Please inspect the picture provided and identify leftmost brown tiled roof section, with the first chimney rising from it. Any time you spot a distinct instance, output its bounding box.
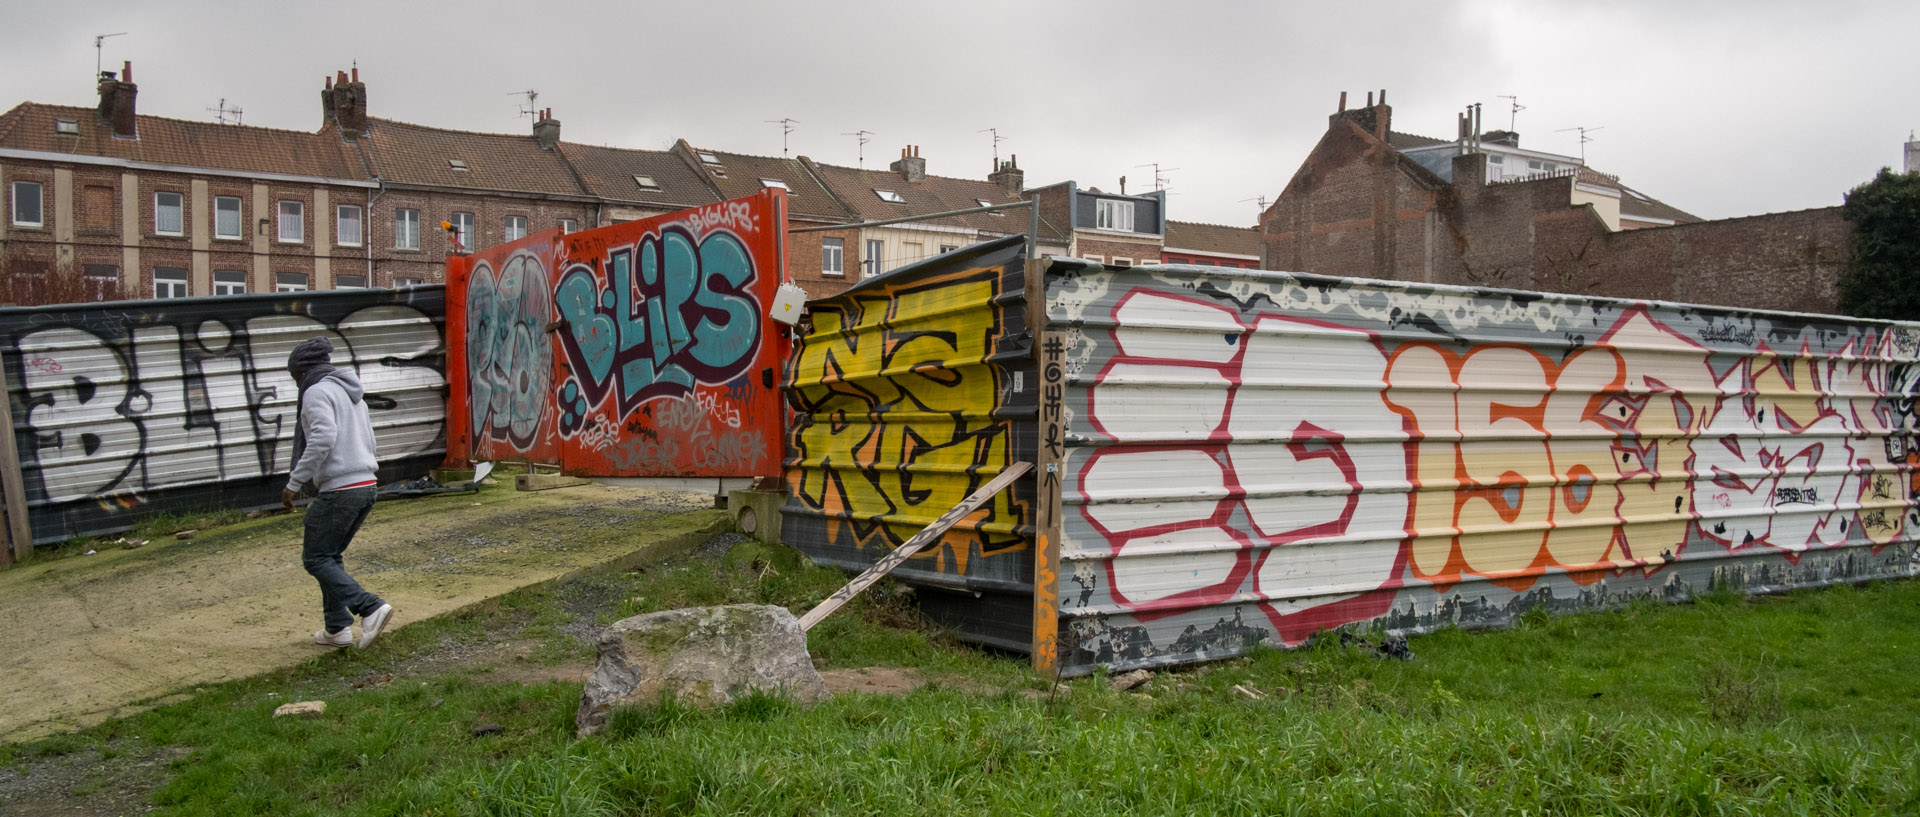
[0,102,367,178]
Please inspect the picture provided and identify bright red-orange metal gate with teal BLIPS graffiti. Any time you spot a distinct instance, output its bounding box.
[449,190,787,476]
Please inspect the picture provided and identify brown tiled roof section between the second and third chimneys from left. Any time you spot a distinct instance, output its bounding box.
[361,117,588,196]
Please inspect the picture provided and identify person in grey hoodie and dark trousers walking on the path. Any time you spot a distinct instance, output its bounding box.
[280,338,394,648]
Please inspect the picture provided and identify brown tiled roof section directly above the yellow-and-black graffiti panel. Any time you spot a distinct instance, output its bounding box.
[803,157,1027,234]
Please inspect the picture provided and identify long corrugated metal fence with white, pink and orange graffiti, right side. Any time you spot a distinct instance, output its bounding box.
[1046,263,1920,673]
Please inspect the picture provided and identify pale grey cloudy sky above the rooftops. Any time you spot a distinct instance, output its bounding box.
[0,0,1920,224]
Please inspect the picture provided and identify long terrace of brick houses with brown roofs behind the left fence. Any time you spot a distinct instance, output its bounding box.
[0,63,1240,303]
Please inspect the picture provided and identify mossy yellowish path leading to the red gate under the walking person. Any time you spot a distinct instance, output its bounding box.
[0,485,724,742]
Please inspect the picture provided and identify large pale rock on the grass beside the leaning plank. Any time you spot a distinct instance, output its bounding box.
[574,604,828,736]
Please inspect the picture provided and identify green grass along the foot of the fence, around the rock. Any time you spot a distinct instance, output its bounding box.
[0,545,1920,815]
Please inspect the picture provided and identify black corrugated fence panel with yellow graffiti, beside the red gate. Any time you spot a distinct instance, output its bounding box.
[781,236,1035,650]
